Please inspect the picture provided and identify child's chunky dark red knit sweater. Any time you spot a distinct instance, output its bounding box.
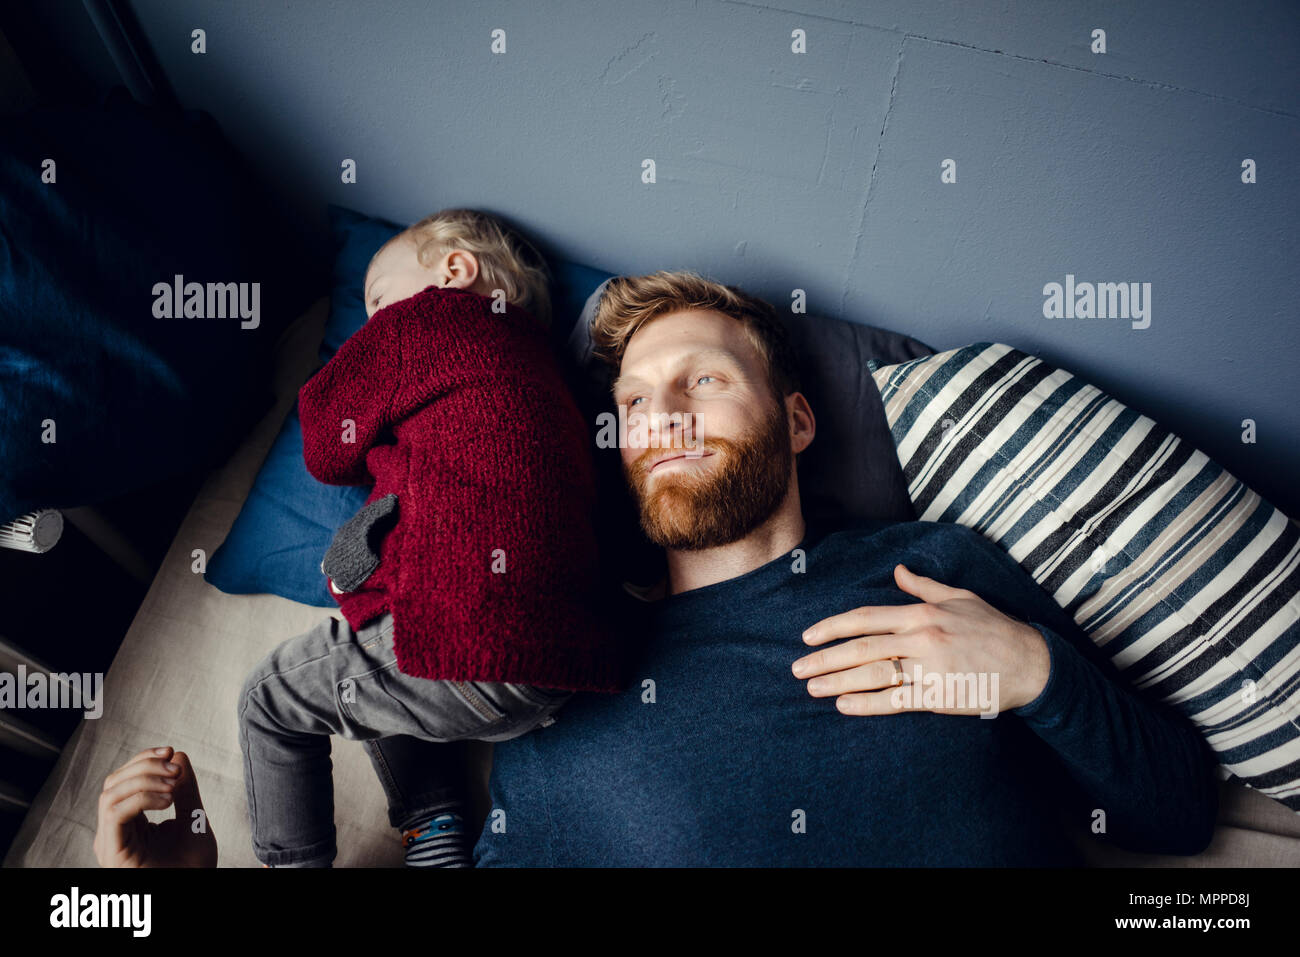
[298,286,623,692]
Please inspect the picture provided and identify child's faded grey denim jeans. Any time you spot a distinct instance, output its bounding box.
[239,614,572,867]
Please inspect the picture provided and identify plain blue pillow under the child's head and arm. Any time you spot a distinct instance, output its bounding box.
[204,205,610,607]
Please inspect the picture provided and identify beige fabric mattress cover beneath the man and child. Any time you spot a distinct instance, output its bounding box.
[4,299,1300,867]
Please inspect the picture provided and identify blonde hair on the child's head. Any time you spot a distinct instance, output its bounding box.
[384,209,551,329]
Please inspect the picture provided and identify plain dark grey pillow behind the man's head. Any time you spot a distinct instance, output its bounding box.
[568,280,935,540]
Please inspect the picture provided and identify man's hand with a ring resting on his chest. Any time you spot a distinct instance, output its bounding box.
[792,564,1052,714]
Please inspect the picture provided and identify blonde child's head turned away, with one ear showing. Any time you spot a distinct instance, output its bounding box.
[363,209,551,328]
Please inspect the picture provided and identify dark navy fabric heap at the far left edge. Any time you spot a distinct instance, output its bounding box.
[0,95,321,521]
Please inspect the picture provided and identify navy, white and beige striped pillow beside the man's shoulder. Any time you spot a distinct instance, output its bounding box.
[868,343,1300,811]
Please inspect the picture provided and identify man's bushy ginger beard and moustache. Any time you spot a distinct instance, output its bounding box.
[625,403,794,551]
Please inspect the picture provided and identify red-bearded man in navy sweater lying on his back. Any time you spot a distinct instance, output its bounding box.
[475,272,1218,866]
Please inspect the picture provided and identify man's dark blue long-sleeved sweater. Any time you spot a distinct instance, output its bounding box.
[475,521,1218,866]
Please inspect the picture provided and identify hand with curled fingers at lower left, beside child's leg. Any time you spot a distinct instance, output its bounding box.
[95,748,217,867]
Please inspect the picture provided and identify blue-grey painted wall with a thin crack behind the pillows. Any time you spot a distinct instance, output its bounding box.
[124,0,1300,515]
